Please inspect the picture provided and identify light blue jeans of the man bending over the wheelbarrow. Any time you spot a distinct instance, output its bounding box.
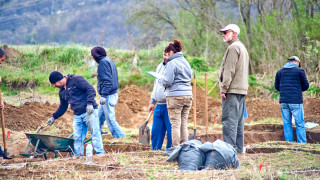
[73,109,104,156]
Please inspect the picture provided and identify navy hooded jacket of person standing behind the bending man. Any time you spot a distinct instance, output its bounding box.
[97,57,119,97]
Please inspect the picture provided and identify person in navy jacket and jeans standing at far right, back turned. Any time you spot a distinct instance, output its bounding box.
[275,56,309,143]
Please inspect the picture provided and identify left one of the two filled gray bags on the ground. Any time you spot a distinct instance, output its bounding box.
[167,140,205,171]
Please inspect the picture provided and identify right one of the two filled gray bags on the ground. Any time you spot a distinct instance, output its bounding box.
[200,139,240,169]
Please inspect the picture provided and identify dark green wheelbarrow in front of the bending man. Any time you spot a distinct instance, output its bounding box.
[20,133,92,160]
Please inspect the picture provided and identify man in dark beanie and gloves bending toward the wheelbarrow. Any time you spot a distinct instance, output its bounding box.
[47,71,104,156]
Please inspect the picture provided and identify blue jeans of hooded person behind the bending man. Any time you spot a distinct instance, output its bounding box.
[98,93,126,138]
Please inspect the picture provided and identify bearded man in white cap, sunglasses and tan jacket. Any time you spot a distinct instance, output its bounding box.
[219,24,249,153]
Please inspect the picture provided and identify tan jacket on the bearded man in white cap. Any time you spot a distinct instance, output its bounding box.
[219,39,249,95]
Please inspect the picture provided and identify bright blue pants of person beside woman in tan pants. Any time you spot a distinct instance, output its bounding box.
[151,104,172,150]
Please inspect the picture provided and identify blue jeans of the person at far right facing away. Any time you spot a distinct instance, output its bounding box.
[281,103,307,143]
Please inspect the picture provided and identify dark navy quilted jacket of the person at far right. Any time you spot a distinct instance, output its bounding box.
[274,62,309,104]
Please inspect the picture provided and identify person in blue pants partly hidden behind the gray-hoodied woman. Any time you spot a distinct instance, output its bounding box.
[149,52,172,150]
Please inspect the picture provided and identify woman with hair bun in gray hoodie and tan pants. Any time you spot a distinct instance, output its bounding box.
[160,39,192,146]
